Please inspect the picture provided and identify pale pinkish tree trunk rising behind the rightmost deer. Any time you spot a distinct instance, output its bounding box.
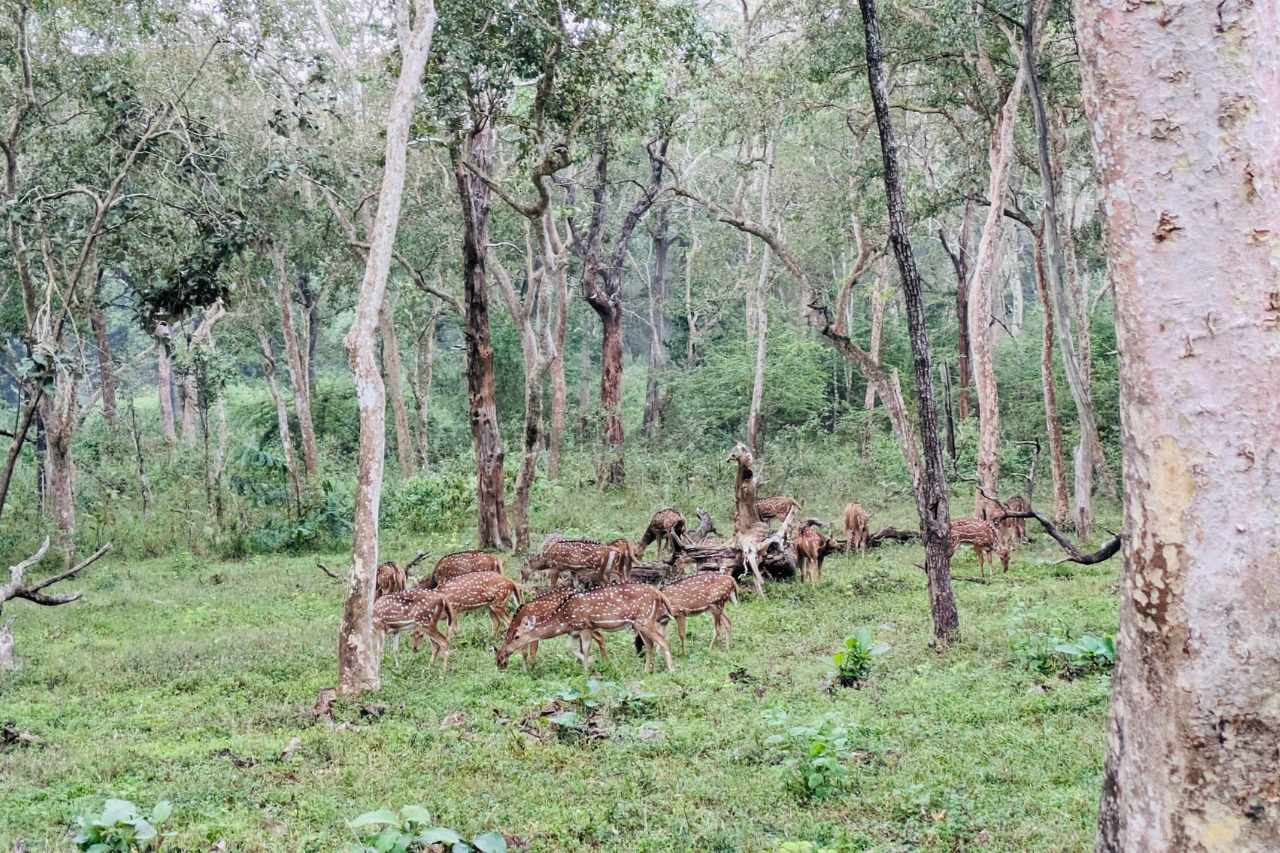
[968,53,1025,517]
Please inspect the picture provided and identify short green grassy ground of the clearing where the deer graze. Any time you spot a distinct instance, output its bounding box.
[0,479,1117,850]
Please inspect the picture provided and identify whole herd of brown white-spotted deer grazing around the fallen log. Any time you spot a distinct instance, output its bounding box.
[372,496,1029,672]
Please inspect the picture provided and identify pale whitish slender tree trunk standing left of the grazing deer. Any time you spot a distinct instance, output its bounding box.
[337,0,435,695]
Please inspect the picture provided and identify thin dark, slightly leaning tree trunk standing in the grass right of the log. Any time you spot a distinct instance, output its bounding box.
[859,0,960,648]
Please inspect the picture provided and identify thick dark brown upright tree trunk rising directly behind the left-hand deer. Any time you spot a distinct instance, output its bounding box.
[453,123,512,548]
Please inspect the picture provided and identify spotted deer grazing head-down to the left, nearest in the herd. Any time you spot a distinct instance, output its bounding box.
[497,584,673,672]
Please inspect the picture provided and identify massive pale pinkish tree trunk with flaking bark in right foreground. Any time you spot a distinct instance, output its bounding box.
[1075,0,1280,853]
